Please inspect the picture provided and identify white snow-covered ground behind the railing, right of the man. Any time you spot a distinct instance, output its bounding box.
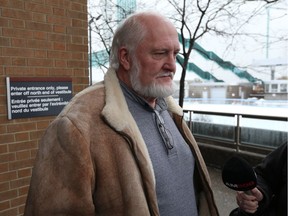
[183,99,288,133]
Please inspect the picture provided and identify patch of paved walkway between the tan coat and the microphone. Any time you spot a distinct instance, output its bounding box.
[208,167,237,216]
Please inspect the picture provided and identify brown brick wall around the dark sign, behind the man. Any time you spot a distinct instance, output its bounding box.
[0,0,89,216]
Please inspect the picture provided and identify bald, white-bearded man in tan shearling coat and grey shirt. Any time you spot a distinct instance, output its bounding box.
[25,12,218,216]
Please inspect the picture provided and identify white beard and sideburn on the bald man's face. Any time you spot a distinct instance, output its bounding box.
[130,57,176,98]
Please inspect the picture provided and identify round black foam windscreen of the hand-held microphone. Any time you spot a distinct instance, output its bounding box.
[222,156,257,191]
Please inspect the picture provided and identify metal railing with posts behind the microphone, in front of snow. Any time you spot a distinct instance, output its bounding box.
[184,110,288,166]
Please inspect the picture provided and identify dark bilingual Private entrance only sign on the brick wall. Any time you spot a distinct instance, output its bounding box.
[6,77,72,120]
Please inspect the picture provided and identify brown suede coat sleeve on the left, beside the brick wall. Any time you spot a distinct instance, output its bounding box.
[24,117,95,216]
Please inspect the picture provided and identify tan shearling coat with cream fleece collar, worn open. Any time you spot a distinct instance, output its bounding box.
[24,69,218,216]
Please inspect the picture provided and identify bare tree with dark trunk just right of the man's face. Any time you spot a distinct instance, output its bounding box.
[164,0,277,106]
